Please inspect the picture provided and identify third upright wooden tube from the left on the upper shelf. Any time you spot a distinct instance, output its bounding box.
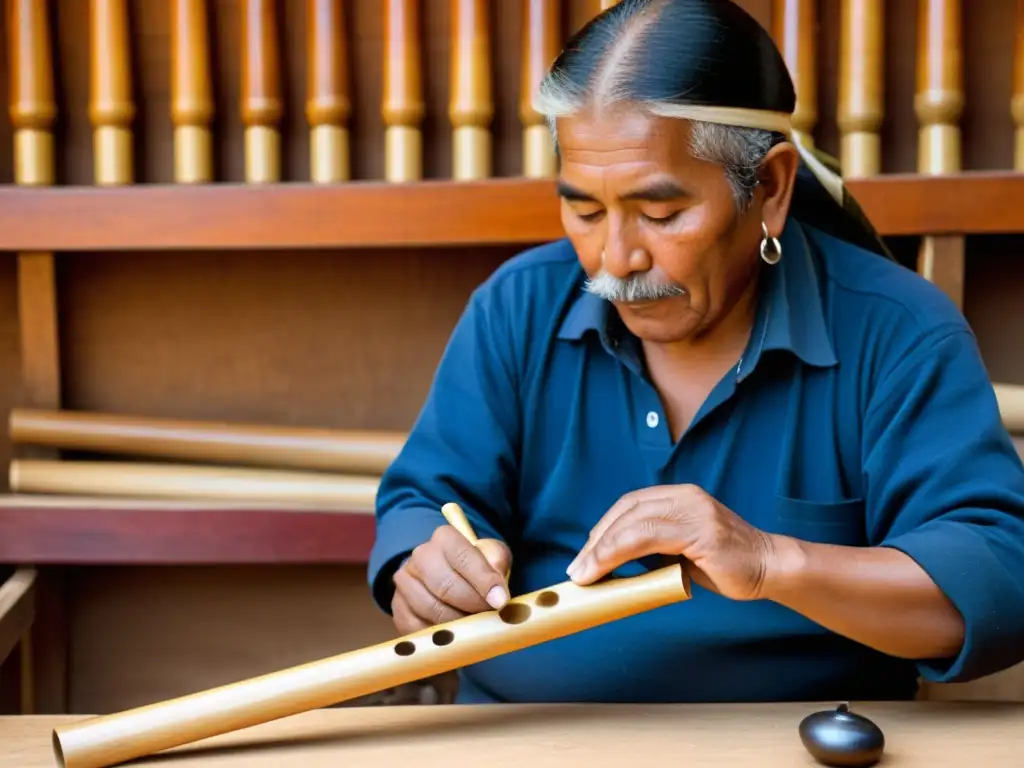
[171,0,215,184]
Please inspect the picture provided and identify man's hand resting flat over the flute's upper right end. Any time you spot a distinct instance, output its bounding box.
[567,485,775,600]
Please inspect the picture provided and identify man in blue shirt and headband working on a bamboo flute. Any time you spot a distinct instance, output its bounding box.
[369,0,1024,702]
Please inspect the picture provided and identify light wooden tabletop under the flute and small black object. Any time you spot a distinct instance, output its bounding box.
[0,701,1024,768]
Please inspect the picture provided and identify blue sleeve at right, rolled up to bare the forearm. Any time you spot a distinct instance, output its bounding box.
[864,324,1024,682]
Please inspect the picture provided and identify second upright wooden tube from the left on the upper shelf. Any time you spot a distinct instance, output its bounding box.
[89,0,135,185]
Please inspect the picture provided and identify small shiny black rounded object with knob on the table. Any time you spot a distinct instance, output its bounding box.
[800,703,886,768]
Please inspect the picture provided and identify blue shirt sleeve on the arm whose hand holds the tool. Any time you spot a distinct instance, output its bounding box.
[368,273,520,613]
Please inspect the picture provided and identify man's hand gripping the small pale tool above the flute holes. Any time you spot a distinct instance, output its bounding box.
[391,525,512,635]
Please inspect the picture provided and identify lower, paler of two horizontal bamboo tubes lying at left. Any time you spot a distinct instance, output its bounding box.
[9,459,380,512]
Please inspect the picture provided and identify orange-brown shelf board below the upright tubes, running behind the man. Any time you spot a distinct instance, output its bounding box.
[0,172,1024,251]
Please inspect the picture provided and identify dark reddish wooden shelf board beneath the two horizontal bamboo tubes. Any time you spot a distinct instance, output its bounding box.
[0,496,375,565]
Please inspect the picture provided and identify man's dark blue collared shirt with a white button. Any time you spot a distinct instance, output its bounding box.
[369,221,1024,702]
